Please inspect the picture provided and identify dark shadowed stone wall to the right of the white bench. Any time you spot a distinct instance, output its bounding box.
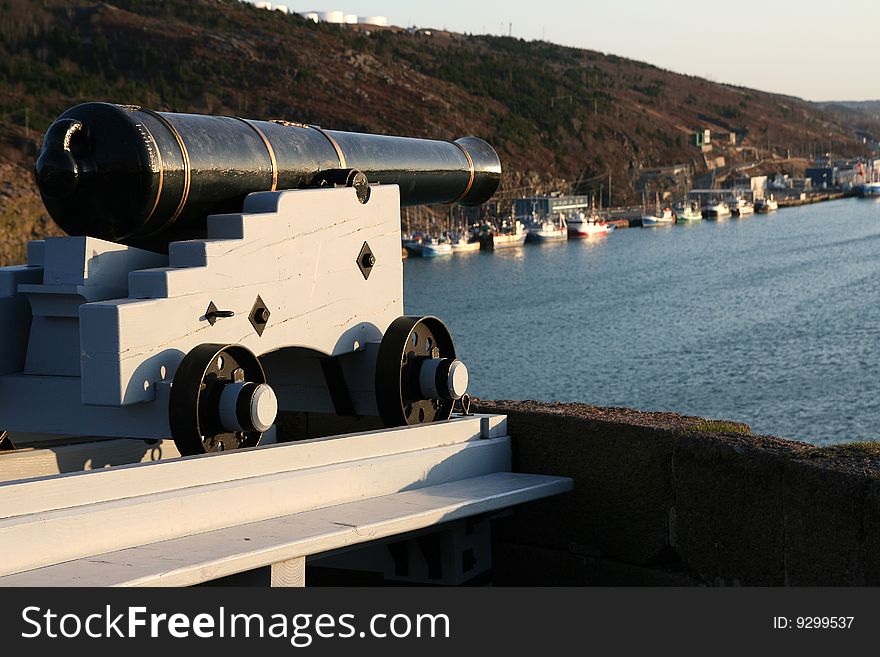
[474,401,880,586]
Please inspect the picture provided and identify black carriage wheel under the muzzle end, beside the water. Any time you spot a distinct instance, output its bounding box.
[375,315,460,427]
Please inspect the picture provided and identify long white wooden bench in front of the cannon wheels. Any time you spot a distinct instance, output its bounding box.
[0,416,571,586]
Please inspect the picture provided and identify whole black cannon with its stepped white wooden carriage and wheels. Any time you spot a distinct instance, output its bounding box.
[0,103,501,454]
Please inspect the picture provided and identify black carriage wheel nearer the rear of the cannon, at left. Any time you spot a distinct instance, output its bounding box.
[168,344,277,455]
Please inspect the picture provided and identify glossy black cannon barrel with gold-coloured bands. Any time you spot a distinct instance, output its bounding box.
[35,103,501,244]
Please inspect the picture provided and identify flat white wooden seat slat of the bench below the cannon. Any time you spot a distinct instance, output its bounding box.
[0,472,572,586]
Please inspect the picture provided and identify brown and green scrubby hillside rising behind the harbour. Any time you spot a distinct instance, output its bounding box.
[0,0,880,261]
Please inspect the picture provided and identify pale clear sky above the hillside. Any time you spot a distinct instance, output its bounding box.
[258,0,880,100]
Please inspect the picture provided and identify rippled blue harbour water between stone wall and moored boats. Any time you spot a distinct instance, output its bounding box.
[404,199,880,444]
